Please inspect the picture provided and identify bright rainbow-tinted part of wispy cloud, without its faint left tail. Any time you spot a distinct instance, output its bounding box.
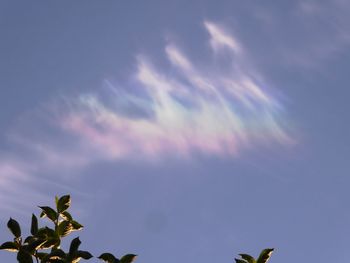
[61,21,293,159]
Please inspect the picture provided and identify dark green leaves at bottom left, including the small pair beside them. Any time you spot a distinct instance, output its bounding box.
[0,195,136,263]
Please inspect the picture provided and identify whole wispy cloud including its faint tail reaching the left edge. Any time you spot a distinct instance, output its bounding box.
[0,21,294,214]
